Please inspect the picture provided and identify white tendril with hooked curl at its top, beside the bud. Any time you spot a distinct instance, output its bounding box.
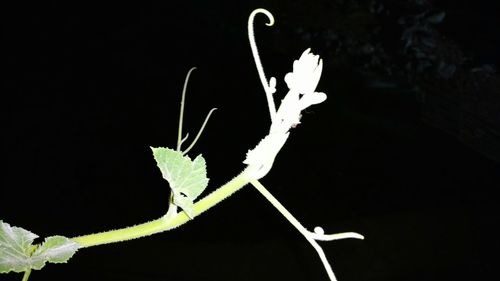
[248,8,276,122]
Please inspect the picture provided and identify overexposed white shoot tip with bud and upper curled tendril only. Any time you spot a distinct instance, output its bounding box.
[243,9,326,179]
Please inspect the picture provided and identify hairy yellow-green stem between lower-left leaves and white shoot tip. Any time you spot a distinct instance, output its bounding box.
[72,167,250,247]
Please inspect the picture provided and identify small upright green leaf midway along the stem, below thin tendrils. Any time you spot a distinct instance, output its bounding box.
[151,147,208,218]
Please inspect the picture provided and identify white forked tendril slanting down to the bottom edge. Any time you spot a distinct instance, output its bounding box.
[250,179,364,281]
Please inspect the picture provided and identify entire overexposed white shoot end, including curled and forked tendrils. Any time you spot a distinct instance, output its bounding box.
[243,9,364,281]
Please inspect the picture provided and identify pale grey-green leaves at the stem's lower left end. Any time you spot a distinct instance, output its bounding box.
[0,221,80,273]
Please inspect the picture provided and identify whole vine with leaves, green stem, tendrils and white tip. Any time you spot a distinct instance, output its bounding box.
[0,9,363,281]
